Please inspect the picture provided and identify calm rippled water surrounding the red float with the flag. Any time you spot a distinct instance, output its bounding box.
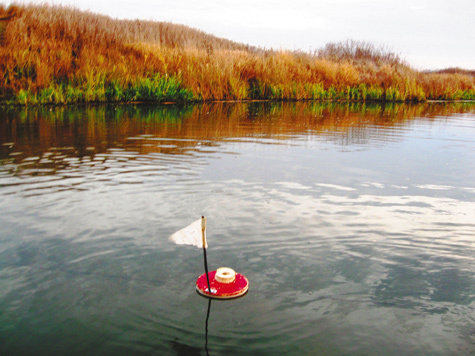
[0,103,475,355]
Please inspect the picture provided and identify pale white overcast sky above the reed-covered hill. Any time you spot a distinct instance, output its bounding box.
[4,0,475,70]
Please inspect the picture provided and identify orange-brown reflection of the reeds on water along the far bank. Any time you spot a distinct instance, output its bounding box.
[0,102,474,170]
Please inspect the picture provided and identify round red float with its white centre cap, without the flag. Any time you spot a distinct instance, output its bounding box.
[196,267,249,299]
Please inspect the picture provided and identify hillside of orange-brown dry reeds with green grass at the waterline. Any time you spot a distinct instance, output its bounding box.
[0,5,475,105]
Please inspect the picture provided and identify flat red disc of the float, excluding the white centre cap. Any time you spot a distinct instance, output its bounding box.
[196,271,249,299]
